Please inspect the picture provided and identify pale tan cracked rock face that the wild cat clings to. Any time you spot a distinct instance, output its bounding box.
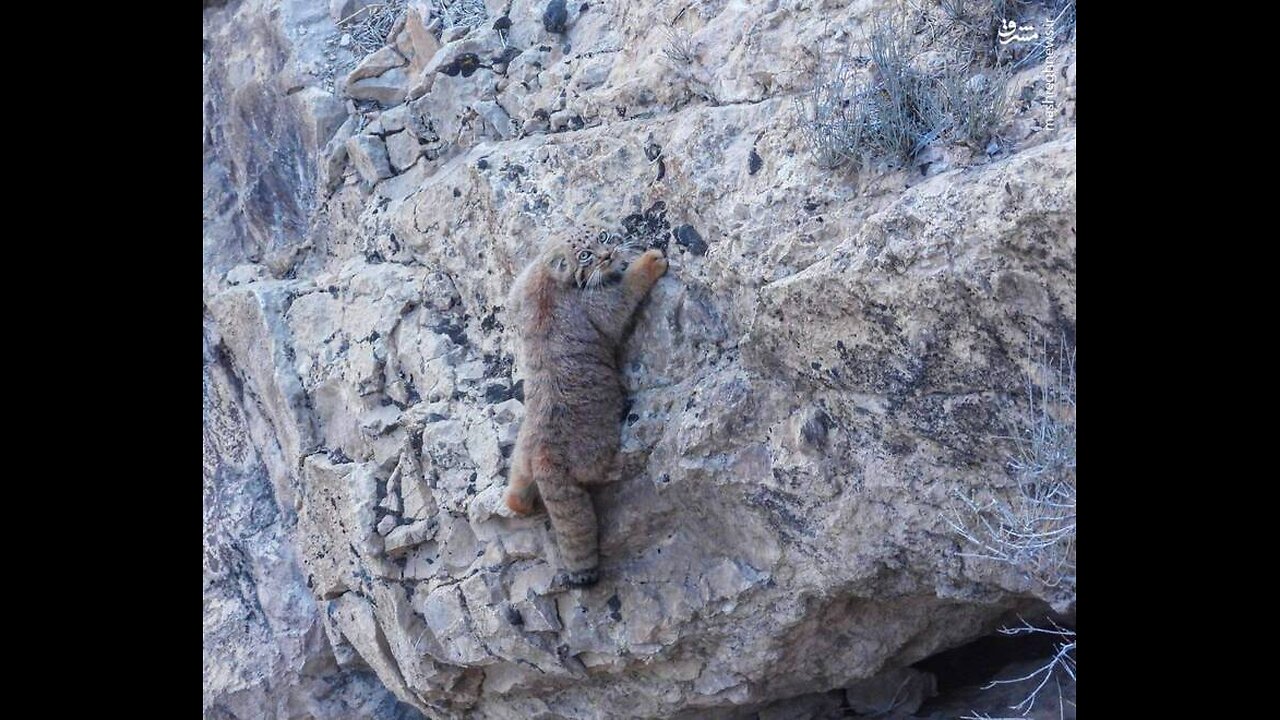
[204,0,1075,719]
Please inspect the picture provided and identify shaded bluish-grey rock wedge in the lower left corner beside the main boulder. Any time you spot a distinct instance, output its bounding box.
[204,334,416,720]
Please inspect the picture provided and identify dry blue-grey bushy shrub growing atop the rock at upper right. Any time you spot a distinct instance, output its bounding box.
[797,0,1075,169]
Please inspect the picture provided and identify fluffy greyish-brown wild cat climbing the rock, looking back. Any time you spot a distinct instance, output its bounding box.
[504,226,667,587]
